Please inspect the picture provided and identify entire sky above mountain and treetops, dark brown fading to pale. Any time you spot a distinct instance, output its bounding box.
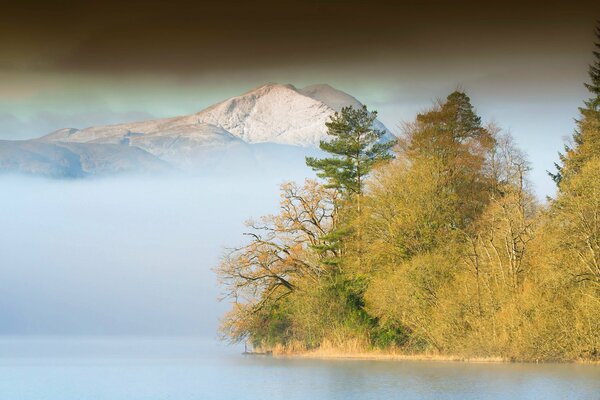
[0,0,600,196]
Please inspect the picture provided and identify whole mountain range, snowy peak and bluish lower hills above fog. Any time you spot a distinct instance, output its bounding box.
[0,83,387,176]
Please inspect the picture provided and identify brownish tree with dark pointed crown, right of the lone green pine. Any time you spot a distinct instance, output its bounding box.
[401,91,496,229]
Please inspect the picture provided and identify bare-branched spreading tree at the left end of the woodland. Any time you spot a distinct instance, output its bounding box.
[216,180,339,338]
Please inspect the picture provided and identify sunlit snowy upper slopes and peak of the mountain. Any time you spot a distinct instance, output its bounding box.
[41,83,390,149]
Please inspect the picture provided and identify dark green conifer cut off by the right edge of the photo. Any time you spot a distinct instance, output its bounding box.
[549,23,600,188]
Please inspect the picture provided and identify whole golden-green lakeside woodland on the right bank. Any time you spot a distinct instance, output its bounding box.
[216,28,600,361]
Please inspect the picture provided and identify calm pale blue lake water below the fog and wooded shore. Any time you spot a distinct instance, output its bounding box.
[0,338,600,400]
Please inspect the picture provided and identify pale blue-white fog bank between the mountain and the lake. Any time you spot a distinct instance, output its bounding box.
[0,170,310,337]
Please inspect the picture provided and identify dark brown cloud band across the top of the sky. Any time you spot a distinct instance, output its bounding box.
[0,0,600,75]
